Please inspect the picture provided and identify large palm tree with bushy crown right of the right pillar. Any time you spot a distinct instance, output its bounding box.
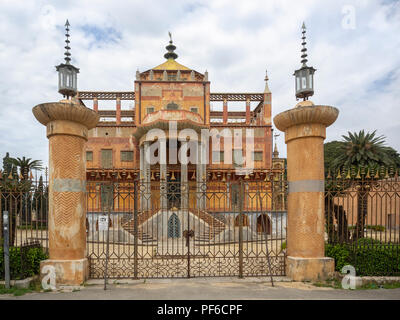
[332,130,400,239]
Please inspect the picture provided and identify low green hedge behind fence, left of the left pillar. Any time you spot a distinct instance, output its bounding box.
[0,247,48,280]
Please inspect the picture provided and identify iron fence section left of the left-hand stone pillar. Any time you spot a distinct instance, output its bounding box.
[0,175,49,279]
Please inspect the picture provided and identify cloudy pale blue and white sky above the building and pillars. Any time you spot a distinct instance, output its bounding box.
[0,0,400,171]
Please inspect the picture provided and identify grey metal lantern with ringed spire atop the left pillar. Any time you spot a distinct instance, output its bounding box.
[56,20,79,99]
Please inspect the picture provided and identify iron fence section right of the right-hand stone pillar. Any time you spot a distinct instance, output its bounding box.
[325,174,400,275]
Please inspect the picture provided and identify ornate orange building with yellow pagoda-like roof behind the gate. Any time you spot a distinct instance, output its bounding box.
[77,39,285,238]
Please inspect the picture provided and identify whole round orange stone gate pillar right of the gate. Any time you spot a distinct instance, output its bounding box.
[274,101,339,281]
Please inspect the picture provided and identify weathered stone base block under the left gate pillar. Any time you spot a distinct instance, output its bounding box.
[40,258,89,287]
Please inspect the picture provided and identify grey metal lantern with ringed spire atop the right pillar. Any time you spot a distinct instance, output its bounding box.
[293,22,316,101]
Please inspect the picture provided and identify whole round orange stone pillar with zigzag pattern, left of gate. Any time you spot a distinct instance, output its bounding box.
[32,100,99,285]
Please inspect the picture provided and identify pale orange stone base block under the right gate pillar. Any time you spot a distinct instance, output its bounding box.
[286,257,335,281]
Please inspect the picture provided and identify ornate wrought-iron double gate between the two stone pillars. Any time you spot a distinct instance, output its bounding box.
[87,173,286,278]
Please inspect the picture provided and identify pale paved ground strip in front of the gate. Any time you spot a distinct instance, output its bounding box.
[0,278,400,300]
